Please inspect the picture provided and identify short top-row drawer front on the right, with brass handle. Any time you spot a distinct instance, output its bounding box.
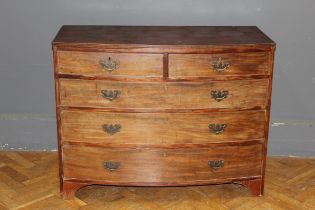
[169,52,270,78]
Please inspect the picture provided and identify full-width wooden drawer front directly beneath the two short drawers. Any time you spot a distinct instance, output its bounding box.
[59,79,268,109]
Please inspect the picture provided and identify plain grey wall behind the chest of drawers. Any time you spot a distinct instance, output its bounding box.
[0,0,315,155]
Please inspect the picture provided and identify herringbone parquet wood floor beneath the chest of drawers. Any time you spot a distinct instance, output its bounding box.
[0,152,315,210]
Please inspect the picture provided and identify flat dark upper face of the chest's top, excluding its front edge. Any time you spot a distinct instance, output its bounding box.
[53,25,275,46]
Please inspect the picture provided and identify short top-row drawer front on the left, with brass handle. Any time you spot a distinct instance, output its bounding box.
[58,51,163,77]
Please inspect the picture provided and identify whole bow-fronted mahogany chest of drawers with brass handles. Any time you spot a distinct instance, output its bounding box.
[53,26,275,199]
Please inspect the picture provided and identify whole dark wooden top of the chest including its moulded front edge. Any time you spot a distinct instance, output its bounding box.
[52,26,275,53]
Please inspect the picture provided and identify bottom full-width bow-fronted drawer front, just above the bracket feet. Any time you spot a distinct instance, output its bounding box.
[62,144,262,185]
